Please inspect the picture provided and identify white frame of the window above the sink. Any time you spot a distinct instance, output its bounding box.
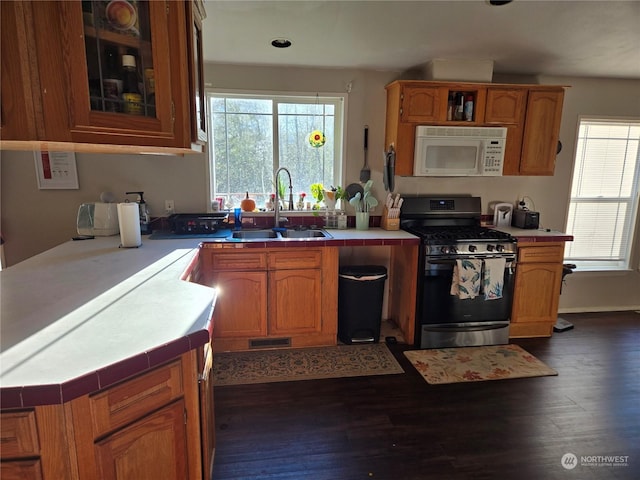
[205,87,348,211]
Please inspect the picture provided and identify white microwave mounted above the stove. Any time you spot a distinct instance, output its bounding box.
[413,126,507,177]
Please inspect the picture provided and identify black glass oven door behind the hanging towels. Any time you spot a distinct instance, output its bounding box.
[418,260,515,324]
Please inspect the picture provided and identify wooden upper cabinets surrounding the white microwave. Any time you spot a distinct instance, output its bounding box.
[385,80,564,176]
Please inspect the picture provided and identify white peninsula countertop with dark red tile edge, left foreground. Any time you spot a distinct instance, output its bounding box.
[0,236,216,408]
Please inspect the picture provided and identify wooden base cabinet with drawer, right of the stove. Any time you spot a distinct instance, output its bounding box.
[509,242,564,338]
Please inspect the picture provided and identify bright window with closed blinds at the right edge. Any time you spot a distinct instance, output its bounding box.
[565,118,640,270]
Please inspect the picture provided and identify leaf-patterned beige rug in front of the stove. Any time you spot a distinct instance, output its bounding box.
[404,345,558,384]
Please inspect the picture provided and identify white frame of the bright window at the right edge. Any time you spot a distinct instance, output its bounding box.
[564,115,640,272]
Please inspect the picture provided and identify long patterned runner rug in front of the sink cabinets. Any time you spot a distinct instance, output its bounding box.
[213,343,404,386]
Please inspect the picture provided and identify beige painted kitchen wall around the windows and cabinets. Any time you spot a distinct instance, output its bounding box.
[1,0,640,480]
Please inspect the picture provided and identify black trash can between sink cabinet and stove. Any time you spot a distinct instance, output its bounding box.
[338,265,387,344]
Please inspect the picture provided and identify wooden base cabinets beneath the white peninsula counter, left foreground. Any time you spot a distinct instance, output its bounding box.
[0,350,213,480]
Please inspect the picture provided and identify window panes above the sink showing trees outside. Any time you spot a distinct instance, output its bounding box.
[208,92,344,208]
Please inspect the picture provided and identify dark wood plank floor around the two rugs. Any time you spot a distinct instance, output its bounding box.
[214,312,640,480]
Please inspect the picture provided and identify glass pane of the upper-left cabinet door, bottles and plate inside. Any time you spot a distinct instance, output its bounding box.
[82,0,156,117]
